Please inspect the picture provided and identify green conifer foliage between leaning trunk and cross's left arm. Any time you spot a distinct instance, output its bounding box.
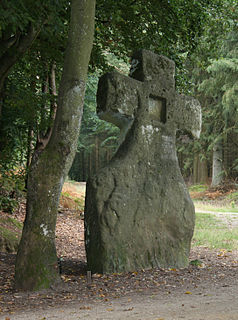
[69,74,119,181]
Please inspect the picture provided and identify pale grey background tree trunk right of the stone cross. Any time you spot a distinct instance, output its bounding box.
[212,140,223,187]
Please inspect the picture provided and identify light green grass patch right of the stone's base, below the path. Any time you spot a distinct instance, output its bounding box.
[192,213,238,250]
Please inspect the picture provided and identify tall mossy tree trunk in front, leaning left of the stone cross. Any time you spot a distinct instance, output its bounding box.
[15,0,95,290]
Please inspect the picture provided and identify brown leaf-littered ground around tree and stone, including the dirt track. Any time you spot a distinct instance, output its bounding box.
[0,184,238,320]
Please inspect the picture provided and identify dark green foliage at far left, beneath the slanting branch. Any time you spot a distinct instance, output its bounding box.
[0,55,58,166]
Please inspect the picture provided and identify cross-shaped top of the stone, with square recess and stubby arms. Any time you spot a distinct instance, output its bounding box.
[97,50,201,137]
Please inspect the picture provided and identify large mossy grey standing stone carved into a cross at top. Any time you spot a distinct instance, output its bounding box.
[85,50,201,273]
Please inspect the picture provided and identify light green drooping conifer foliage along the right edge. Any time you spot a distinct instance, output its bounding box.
[199,27,238,178]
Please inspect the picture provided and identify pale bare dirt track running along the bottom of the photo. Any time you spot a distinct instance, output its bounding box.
[1,278,238,320]
